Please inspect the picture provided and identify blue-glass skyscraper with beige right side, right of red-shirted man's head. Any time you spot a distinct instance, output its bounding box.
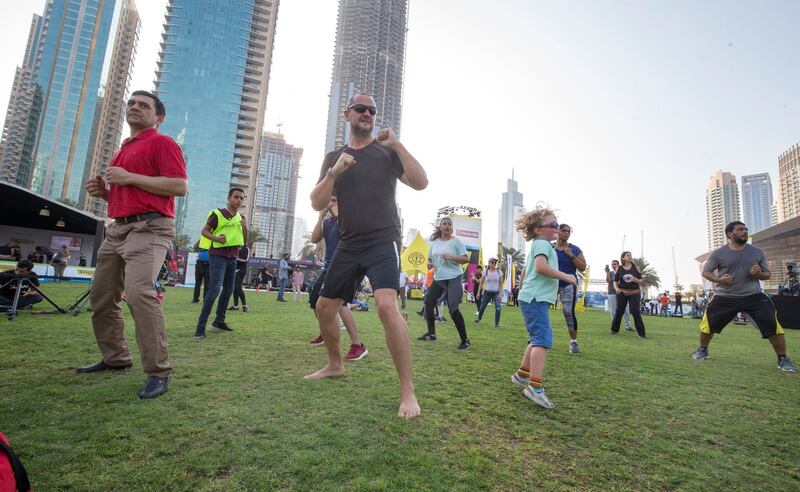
[155,0,279,238]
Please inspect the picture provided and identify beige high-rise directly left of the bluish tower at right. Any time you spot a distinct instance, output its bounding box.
[706,171,741,250]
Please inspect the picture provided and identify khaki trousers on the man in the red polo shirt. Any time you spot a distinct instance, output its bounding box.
[90,217,175,377]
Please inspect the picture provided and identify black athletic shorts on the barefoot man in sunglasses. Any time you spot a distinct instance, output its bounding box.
[319,241,400,301]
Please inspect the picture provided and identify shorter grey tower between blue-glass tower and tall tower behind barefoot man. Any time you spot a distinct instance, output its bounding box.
[251,132,303,258]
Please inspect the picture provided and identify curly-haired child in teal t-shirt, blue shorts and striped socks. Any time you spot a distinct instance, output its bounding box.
[511,206,577,409]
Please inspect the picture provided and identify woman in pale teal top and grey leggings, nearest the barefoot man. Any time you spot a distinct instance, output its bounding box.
[418,217,470,350]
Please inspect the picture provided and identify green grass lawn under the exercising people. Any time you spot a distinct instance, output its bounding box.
[0,285,800,491]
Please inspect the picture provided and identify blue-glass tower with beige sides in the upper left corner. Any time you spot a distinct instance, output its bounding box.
[3,0,139,209]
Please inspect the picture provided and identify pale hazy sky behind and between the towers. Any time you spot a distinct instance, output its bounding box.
[0,0,800,290]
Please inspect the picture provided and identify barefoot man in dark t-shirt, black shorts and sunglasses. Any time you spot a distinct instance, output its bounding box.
[306,94,428,418]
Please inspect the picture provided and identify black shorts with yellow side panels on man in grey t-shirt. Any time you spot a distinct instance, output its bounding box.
[700,293,783,338]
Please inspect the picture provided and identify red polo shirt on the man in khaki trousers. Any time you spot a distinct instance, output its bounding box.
[108,128,186,218]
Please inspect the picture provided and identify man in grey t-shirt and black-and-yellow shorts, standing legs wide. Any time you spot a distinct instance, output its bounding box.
[692,221,797,372]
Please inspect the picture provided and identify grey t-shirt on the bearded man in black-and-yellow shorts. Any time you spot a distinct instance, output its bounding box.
[703,244,769,297]
